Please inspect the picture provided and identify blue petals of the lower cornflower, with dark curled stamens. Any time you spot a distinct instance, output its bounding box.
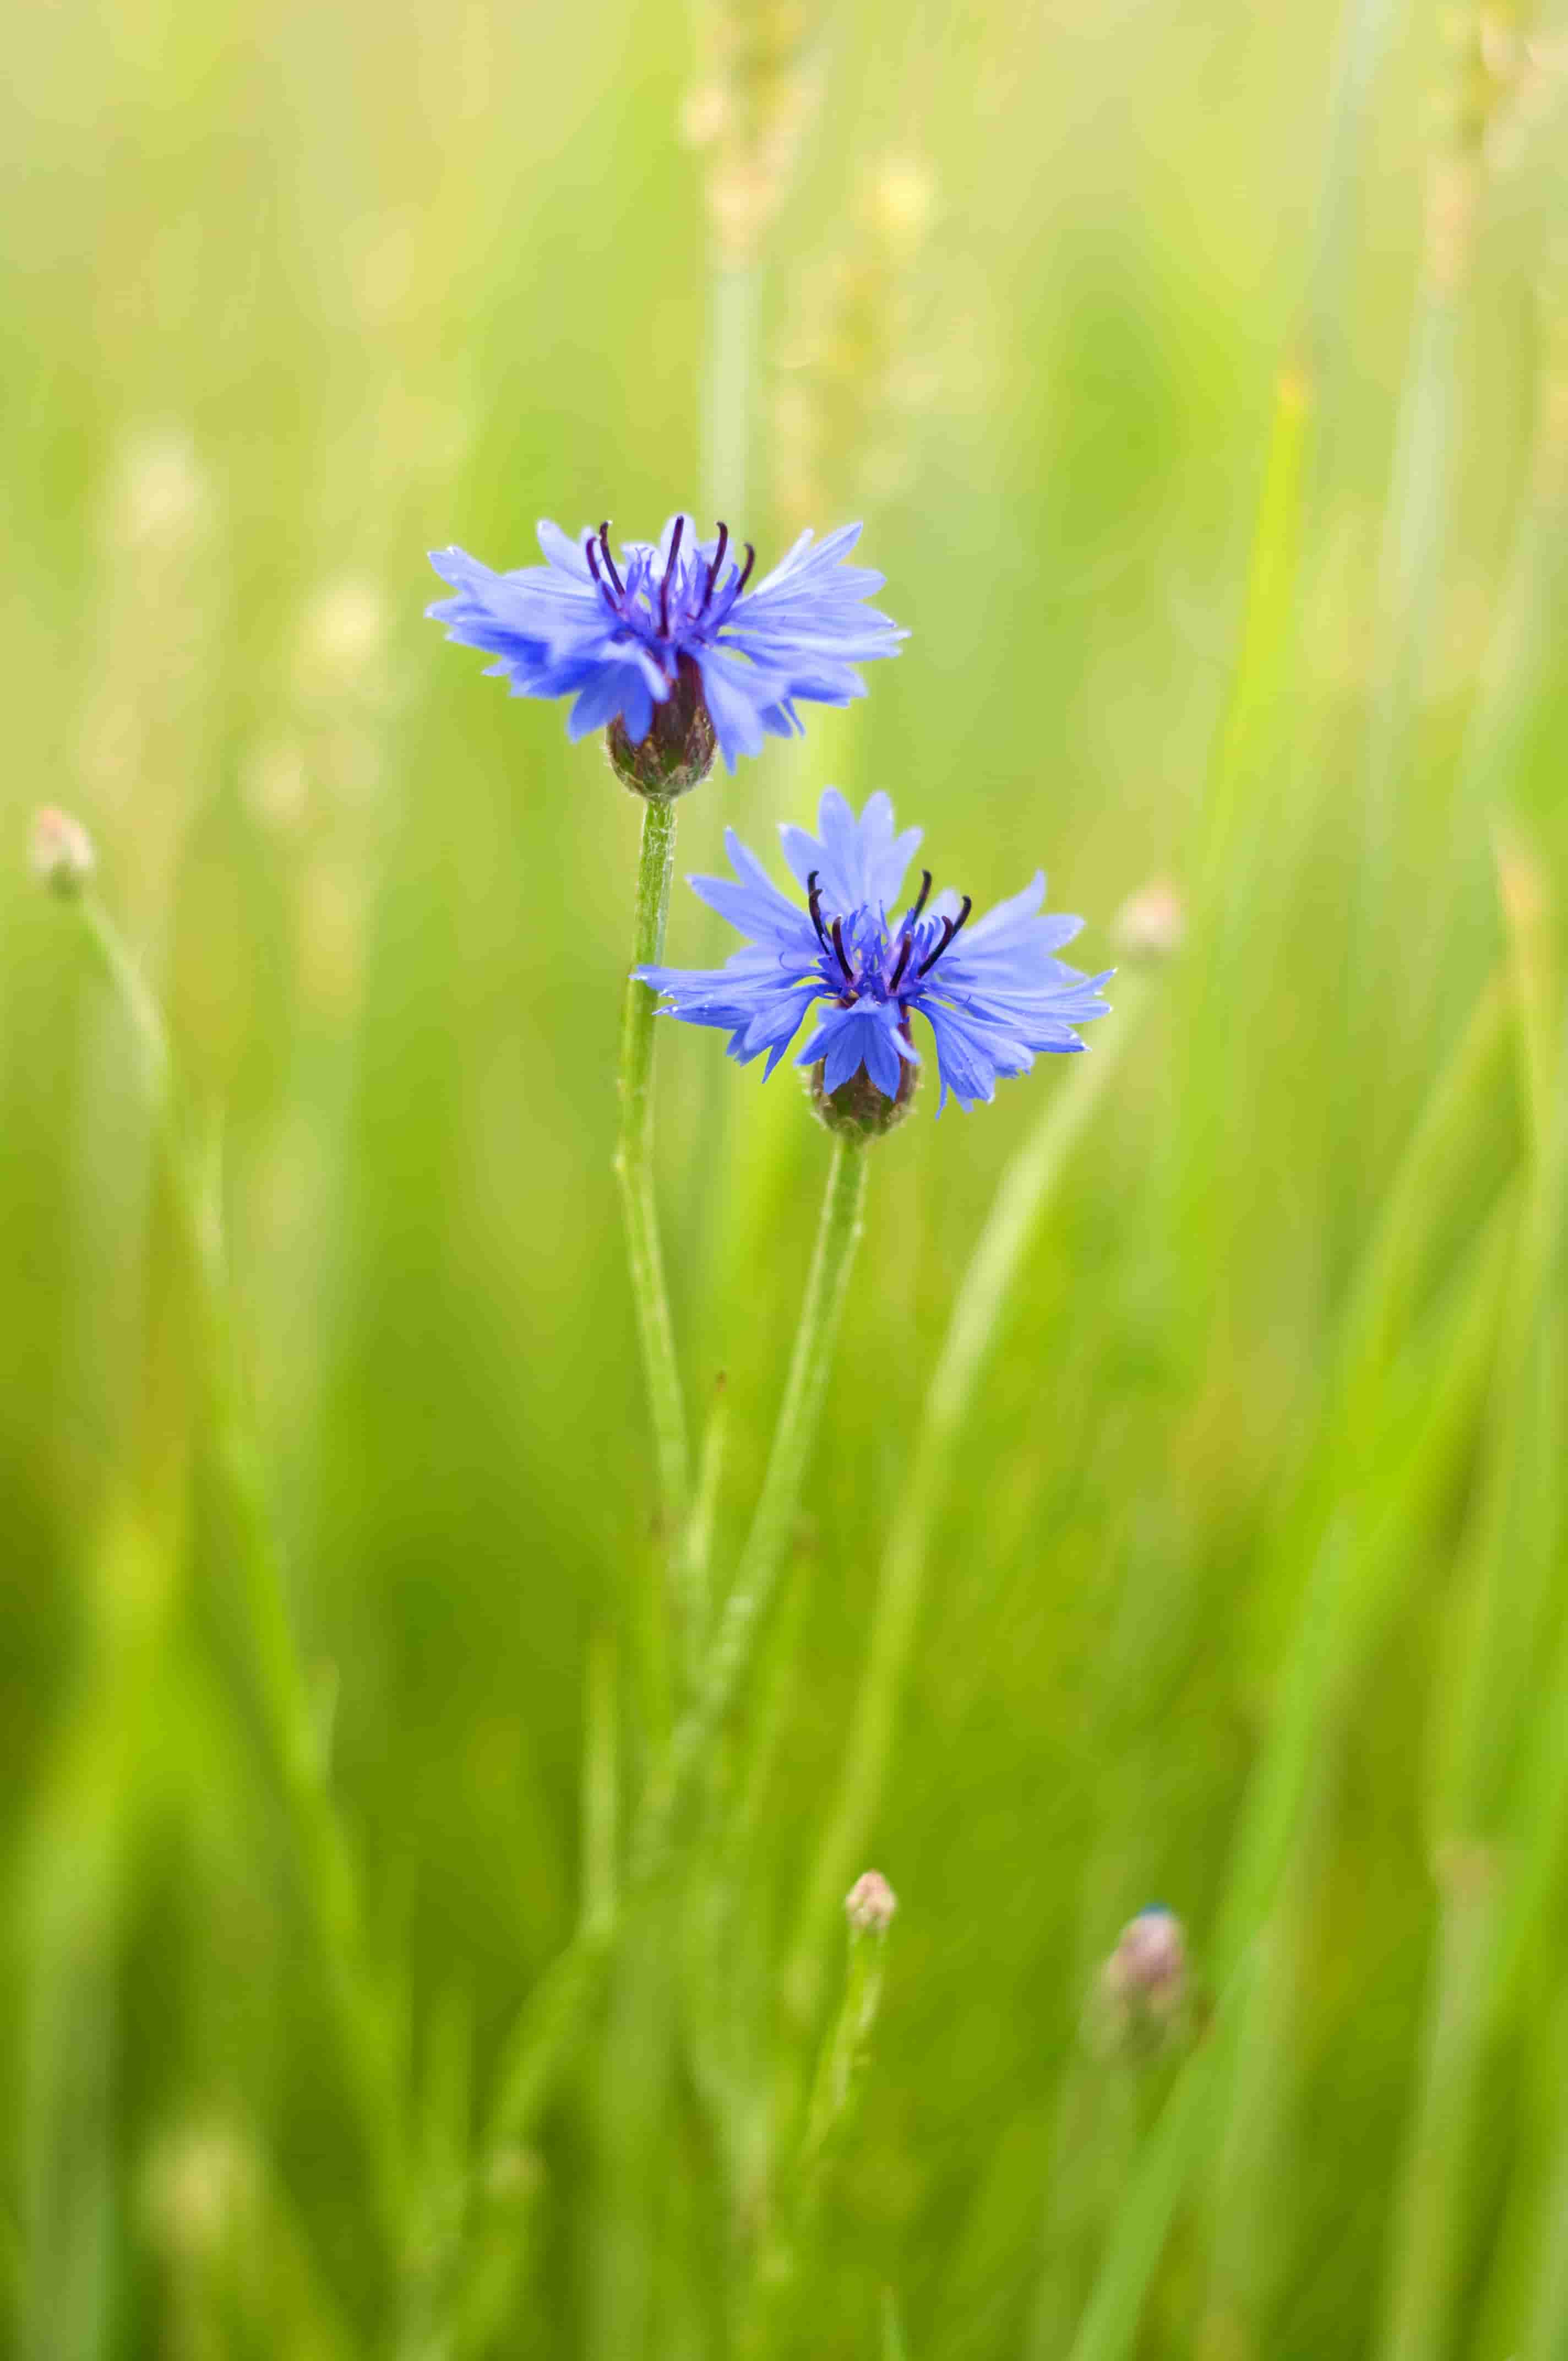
[633,786,1110,1112]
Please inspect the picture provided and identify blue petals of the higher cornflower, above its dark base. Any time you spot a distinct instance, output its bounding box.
[427,515,905,770]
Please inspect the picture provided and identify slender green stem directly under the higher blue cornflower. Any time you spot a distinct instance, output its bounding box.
[616,796,689,1535]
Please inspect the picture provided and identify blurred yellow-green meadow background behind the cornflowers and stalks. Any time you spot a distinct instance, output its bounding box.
[0,0,1568,2361]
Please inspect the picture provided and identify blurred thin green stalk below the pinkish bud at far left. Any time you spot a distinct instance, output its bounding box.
[78,897,404,2257]
